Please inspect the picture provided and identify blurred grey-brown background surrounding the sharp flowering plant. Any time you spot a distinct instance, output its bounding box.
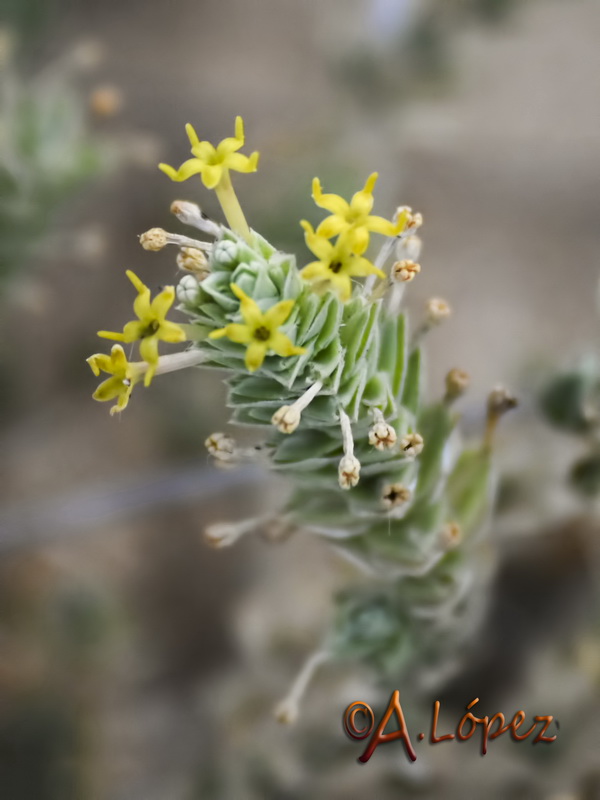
[0,0,600,800]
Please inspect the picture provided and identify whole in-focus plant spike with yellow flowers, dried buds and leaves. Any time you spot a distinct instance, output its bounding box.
[88,117,514,720]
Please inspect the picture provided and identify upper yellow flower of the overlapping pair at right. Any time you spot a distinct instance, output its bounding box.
[313,172,406,255]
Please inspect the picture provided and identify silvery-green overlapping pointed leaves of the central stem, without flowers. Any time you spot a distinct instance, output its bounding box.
[179,230,490,673]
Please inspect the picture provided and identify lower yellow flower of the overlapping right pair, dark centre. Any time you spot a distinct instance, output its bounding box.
[300,220,385,303]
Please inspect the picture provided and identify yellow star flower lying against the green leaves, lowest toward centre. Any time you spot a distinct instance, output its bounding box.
[209,283,306,372]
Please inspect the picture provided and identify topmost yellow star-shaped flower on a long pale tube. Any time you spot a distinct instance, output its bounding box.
[158,117,258,189]
